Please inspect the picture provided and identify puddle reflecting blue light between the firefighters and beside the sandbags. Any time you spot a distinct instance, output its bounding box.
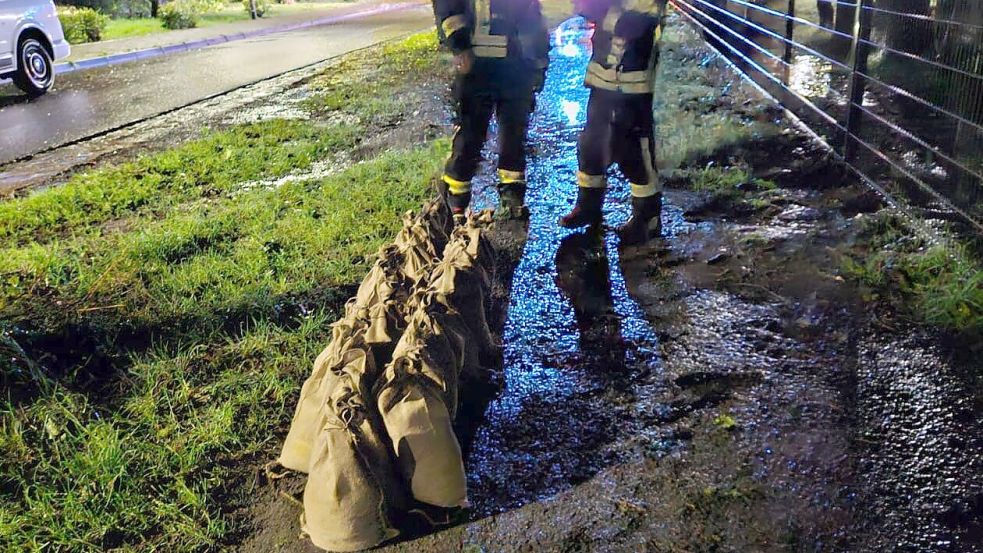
[467,20,693,516]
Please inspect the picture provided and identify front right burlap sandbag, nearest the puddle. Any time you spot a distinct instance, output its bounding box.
[376,364,468,508]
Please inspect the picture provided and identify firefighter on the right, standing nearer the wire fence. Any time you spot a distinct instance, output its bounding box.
[560,0,666,246]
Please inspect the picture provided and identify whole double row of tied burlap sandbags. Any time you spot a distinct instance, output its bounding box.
[279,204,496,551]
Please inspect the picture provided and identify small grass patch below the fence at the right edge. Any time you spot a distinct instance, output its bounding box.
[842,212,983,338]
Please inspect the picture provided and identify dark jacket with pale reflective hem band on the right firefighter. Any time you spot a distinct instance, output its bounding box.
[578,0,666,94]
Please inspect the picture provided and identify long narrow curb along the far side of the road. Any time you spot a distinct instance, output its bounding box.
[55,2,424,75]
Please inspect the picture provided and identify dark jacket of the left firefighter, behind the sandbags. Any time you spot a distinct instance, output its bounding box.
[433,0,550,71]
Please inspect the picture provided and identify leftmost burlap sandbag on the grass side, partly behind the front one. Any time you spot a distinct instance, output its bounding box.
[277,319,378,472]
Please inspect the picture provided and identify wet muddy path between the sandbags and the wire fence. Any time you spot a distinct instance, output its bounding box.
[241,14,983,552]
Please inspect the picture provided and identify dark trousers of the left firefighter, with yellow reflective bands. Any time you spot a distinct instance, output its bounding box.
[444,67,534,194]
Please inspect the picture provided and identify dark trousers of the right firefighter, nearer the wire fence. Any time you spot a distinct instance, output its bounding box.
[577,88,662,198]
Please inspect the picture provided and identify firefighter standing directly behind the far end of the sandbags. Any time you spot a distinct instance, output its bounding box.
[433,0,549,221]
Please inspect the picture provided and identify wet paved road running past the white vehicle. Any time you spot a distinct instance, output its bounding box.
[0,4,433,164]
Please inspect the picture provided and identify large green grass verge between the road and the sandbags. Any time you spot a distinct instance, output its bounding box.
[0,31,448,551]
